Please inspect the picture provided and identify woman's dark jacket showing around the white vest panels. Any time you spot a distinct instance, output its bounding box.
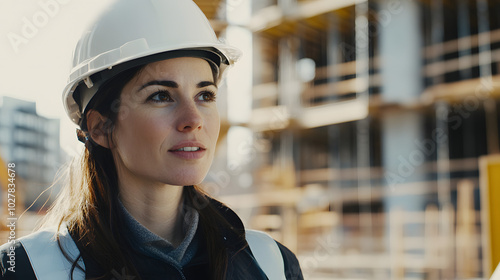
[0,200,303,280]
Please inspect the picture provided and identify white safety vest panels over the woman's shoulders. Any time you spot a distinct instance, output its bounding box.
[18,228,286,280]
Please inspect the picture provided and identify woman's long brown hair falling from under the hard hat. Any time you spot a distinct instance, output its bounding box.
[42,63,242,279]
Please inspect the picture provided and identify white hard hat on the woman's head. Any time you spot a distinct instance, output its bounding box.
[63,0,241,124]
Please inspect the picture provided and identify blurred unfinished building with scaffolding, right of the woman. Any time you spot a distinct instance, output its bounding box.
[211,0,500,279]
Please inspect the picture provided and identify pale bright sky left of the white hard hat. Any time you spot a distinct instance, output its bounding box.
[0,0,115,155]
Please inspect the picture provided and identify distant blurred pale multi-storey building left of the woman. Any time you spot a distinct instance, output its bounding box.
[0,97,66,210]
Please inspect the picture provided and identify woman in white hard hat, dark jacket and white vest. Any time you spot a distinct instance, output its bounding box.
[1,0,302,280]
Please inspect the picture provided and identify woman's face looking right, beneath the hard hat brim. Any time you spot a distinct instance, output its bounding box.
[111,57,220,186]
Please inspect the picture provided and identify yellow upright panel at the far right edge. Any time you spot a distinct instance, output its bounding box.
[479,155,500,278]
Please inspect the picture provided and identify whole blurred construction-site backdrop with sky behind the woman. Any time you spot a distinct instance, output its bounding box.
[0,0,500,280]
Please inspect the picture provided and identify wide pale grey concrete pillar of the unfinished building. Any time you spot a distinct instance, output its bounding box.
[378,0,428,210]
